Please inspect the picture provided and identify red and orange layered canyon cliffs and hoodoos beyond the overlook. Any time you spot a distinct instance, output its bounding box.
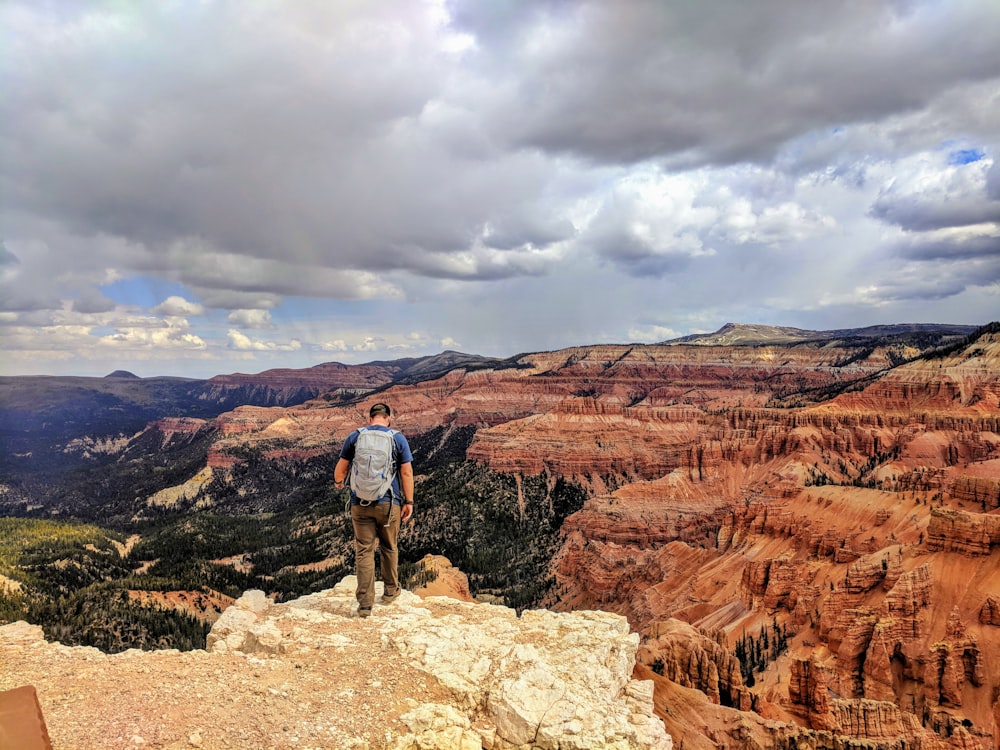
[1,324,1000,750]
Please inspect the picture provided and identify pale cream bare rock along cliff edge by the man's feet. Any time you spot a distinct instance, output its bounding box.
[208,576,672,750]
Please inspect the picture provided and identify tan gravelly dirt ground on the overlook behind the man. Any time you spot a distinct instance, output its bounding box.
[0,612,451,750]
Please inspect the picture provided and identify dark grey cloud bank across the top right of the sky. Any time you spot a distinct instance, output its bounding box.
[455,0,1000,164]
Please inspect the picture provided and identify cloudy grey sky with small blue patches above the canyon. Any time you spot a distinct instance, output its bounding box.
[0,0,1000,378]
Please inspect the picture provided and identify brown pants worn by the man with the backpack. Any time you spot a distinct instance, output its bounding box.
[351,503,399,609]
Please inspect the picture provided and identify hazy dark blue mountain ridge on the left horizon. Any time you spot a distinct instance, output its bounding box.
[0,351,502,496]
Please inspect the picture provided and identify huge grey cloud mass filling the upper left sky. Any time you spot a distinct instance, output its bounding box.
[0,3,596,294]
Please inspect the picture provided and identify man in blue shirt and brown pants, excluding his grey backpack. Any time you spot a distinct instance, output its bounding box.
[333,403,413,617]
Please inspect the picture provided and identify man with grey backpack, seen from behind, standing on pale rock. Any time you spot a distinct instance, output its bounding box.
[333,403,413,617]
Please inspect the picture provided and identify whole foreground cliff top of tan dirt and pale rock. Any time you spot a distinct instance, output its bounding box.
[0,576,673,750]
